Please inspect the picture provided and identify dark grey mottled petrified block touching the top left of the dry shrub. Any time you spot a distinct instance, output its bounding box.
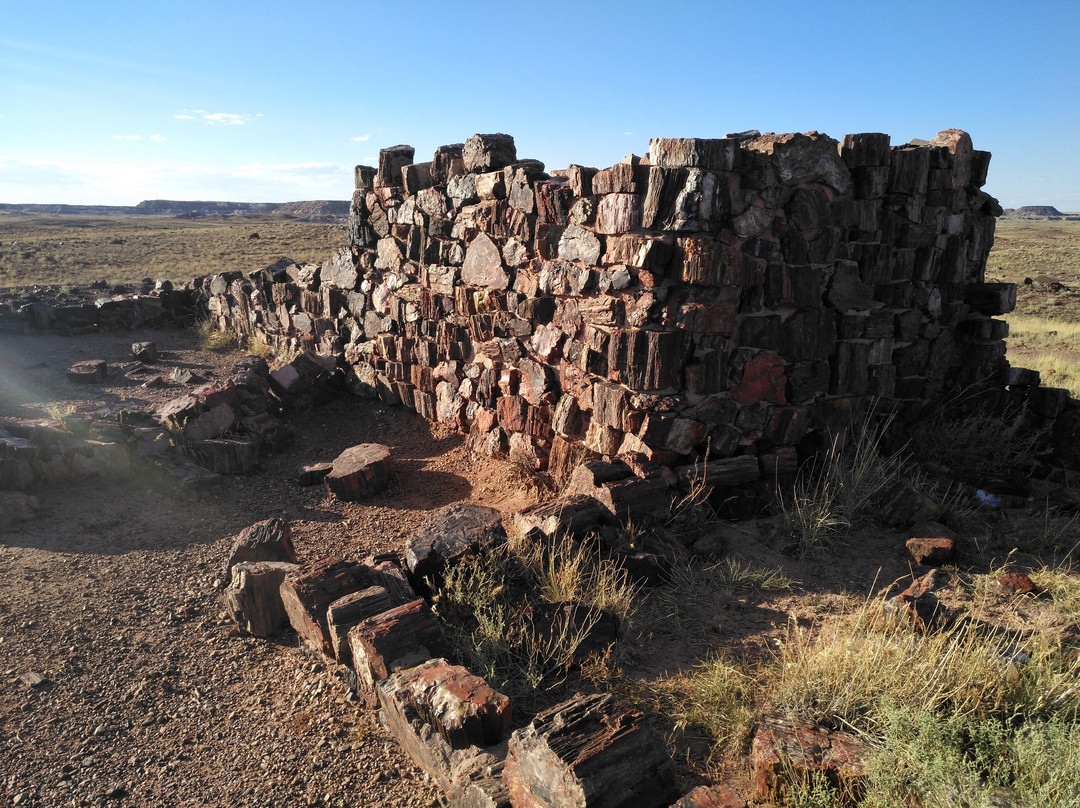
[405,504,507,580]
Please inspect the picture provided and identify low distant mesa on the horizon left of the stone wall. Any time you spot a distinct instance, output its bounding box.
[0,199,349,221]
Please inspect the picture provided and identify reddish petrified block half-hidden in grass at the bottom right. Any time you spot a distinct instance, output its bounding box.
[751,715,869,800]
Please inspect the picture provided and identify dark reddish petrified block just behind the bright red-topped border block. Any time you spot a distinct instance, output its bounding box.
[348,600,441,706]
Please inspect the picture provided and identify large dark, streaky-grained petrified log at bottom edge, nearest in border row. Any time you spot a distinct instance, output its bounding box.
[502,693,678,808]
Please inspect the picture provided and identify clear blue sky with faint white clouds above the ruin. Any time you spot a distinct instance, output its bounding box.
[0,0,1080,211]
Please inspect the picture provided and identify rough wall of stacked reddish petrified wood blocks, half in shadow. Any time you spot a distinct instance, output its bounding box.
[202,130,1015,476]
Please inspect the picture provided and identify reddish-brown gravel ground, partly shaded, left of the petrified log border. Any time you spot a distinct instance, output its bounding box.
[0,332,536,807]
